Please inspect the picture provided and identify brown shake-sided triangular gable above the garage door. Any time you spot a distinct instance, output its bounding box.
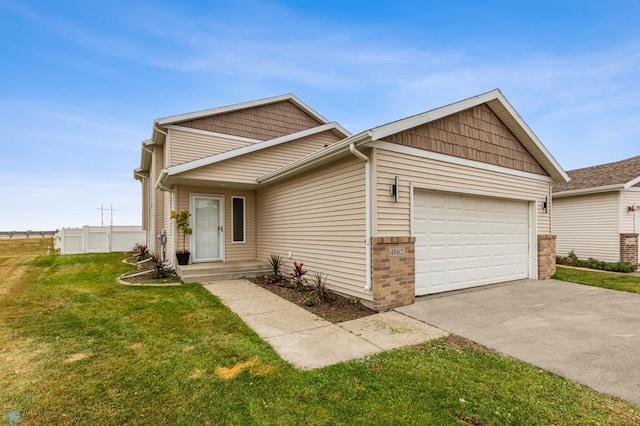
[385,104,547,176]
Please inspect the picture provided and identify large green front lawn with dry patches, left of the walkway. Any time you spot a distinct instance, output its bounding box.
[0,254,640,426]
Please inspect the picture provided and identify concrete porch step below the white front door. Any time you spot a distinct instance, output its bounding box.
[176,261,270,283]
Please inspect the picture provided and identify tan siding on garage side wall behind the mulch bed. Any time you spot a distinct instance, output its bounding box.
[257,157,364,300]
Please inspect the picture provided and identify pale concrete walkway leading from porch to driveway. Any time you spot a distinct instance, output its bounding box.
[204,279,448,369]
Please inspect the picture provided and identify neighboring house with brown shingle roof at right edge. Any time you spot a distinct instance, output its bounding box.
[552,156,640,264]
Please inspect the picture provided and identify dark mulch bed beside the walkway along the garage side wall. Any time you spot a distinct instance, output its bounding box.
[248,277,376,323]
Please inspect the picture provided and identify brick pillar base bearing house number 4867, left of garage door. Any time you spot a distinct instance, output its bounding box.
[371,237,416,311]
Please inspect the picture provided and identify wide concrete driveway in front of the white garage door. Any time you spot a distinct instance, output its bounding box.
[396,280,640,406]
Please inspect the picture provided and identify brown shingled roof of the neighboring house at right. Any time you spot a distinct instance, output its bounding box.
[553,155,640,197]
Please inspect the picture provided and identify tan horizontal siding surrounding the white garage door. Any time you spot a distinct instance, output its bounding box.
[374,149,551,236]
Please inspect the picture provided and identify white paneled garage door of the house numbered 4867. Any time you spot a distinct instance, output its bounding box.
[413,191,529,295]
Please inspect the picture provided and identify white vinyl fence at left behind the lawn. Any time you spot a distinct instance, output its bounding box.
[54,226,147,254]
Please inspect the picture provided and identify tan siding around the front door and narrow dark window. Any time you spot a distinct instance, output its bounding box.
[176,186,257,262]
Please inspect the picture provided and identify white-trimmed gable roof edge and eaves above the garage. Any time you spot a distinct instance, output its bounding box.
[258,89,569,183]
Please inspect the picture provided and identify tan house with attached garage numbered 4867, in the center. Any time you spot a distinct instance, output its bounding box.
[134,90,568,310]
